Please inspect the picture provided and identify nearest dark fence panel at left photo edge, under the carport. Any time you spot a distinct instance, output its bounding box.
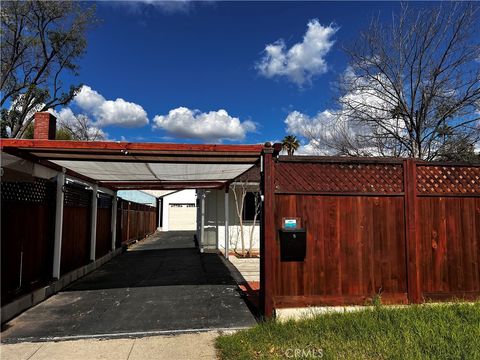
[1,179,55,304]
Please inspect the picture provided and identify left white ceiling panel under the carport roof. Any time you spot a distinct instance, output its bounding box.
[52,160,158,181]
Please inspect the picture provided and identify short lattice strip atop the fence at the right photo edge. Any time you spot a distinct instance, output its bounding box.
[417,165,480,194]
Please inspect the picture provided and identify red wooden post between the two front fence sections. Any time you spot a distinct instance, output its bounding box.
[403,159,422,303]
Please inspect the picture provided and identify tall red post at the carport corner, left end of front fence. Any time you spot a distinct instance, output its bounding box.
[260,147,275,318]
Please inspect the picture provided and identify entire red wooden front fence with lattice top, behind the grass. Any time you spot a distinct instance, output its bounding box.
[261,153,480,315]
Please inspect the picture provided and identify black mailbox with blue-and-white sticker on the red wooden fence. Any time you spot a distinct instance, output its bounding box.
[278,218,307,261]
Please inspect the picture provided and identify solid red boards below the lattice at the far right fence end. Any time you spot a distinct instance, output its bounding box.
[419,197,480,293]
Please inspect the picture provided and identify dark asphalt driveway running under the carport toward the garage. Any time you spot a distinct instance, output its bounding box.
[1,232,256,342]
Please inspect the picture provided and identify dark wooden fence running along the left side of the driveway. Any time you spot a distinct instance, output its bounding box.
[1,178,156,304]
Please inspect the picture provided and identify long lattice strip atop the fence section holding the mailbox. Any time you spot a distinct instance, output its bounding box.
[275,162,403,194]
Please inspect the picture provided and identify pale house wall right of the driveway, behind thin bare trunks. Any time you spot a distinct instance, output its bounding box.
[202,186,260,252]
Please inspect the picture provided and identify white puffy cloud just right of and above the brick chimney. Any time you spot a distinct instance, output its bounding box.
[74,85,148,127]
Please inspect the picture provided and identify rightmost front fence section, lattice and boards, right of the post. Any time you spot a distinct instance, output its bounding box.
[416,163,480,300]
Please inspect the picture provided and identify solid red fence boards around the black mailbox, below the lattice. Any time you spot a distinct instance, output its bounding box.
[274,195,407,307]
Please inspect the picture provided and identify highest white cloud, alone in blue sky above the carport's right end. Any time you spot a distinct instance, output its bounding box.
[256,19,338,86]
